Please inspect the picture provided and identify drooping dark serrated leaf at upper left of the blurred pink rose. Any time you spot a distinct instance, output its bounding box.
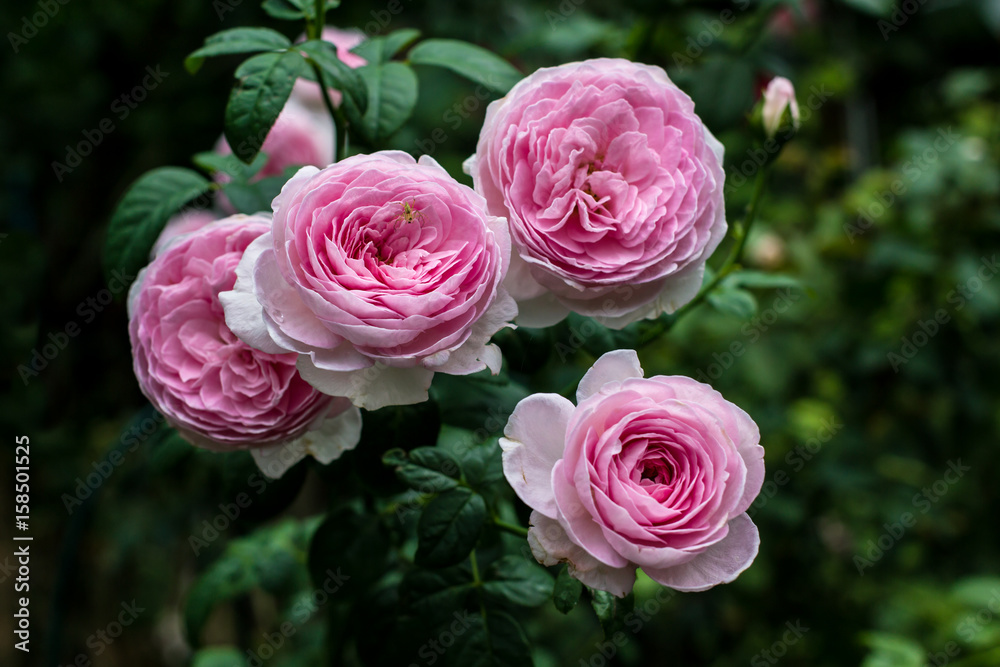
[226,51,306,163]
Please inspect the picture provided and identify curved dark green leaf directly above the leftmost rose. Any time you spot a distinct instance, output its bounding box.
[104,167,212,288]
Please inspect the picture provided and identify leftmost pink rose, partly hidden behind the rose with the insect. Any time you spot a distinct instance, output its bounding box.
[129,215,361,476]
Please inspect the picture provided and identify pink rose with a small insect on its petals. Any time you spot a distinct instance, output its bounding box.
[221,151,517,410]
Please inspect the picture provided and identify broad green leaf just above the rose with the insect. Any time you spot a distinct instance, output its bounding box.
[356,62,417,145]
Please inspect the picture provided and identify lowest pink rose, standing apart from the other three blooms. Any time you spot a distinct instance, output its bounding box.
[500,350,764,597]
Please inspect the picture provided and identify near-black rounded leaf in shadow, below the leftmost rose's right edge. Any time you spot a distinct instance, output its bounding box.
[309,507,389,596]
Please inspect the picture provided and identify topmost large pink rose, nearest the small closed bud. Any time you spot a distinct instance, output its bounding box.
[466,58,726,328]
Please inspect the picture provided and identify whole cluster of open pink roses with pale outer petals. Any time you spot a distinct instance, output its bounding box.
[129,44,764,595]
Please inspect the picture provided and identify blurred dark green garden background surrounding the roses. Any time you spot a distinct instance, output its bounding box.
[0,0,1000,667]
